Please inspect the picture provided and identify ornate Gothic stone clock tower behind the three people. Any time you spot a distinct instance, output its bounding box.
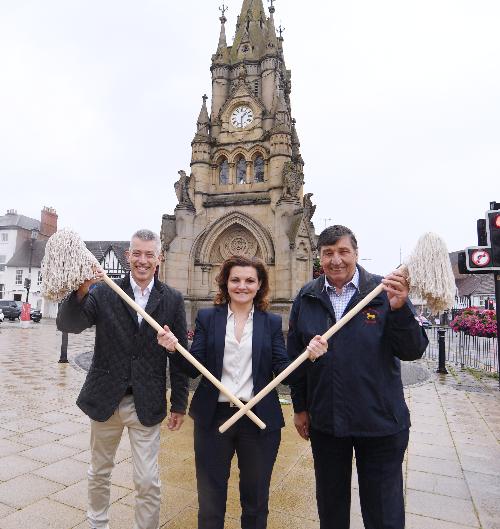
[160,0,315,325]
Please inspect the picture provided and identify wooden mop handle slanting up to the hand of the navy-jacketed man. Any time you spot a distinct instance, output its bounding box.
[219,284,384,433]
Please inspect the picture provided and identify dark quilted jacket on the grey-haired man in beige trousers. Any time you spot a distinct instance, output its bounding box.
[57,275,188,426]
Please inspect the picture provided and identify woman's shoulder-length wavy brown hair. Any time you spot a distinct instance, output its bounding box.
[214,255,269,311]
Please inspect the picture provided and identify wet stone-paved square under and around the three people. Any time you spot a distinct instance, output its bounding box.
[0,320,500,529]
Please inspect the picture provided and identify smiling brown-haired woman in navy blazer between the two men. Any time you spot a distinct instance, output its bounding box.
[158,256,327,529]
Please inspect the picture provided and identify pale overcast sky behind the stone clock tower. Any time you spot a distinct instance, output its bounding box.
[0,0,500,273]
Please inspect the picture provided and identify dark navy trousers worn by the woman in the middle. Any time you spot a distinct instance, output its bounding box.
[194,403,281,529]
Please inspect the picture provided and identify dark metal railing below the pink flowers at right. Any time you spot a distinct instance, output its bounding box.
[424,326,498,373]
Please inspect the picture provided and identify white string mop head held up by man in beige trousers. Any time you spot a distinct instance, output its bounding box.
[41,229,99,302]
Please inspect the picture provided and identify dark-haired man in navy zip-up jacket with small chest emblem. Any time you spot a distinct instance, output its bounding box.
[287,225,428,529]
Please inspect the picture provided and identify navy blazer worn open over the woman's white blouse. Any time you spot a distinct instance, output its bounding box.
[179,305,290,432]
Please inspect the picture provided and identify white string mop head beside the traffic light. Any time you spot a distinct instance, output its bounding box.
[406,233,456,313]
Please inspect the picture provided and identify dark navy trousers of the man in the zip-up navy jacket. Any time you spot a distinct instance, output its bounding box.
[310,428,409,529]
